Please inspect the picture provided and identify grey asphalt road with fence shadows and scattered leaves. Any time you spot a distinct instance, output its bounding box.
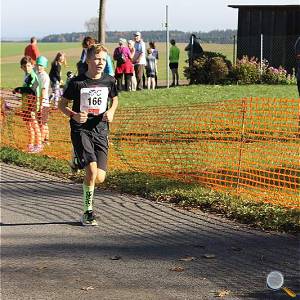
[1,164,300,300]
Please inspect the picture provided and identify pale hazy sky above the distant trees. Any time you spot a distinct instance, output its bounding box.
[1,0,300,39]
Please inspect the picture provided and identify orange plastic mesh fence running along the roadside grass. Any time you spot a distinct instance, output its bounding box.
[1,91,300,208]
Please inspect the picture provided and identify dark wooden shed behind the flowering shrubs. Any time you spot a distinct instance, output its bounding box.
[229,5,300,72]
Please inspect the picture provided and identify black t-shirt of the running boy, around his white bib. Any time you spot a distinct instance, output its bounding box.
[63,73,118,132]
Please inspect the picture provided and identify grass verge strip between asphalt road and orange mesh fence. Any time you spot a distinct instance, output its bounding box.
[0,147,300,233]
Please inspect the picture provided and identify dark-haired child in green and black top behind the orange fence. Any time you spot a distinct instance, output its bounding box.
[14,56,43,153]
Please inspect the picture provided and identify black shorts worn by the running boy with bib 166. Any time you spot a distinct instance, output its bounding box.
[71,130,108,171]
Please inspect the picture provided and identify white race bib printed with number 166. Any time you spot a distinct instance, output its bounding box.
[80,87,108,116]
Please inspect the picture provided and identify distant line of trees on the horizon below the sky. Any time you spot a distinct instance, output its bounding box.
[41,29,236,44]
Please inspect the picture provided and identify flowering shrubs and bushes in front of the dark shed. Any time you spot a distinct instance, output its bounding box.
[184,52,296,84]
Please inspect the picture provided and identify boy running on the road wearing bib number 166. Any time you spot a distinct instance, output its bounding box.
[58,44,118,226]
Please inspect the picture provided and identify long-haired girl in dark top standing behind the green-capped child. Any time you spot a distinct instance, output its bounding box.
[49,52,66,108]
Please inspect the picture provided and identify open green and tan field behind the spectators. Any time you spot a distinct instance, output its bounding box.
[1,42,232,88]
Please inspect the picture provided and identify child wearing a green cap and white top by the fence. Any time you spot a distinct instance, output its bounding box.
[36,56,50,145]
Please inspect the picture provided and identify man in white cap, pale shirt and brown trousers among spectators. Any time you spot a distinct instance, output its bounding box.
[133,31,146,90]
